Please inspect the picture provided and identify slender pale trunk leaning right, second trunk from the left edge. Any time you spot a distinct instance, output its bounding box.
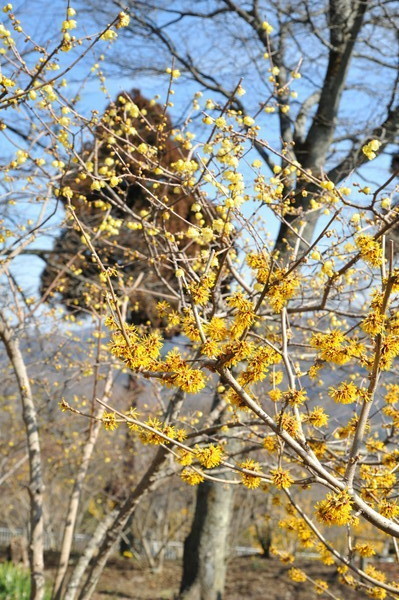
[53,369,113,600]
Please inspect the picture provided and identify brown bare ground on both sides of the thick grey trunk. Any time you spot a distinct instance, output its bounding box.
[88,556,399,600]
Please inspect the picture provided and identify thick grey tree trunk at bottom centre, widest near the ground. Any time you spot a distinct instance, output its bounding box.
[179,481,233,600]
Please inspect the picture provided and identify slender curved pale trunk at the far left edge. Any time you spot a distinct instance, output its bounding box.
[0,314,45,600]
